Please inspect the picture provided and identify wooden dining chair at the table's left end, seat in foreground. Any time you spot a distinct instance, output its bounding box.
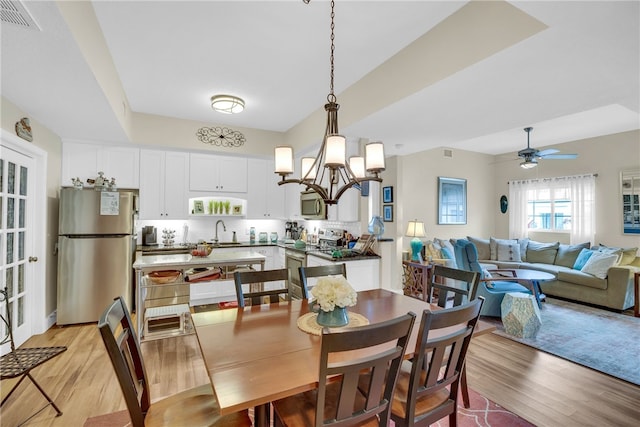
[98,297,252,427]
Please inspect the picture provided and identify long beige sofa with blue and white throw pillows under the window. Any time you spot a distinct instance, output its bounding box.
[425,236,640,311]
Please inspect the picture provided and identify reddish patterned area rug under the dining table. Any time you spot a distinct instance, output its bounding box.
[84,389,533,427]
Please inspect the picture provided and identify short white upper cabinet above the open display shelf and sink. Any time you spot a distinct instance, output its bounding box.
[189,153,247,193]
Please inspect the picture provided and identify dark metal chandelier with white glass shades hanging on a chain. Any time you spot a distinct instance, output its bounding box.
[275,0,385,205]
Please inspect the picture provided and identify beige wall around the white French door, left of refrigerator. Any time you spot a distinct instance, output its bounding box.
[0,97,62,315]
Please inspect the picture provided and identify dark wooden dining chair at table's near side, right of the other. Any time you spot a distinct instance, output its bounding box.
[391,297,484,427]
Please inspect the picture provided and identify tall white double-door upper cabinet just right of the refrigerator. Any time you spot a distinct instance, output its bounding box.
[139,150,189,219]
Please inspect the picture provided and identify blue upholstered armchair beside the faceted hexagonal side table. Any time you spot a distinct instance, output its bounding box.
[453,239,531,317]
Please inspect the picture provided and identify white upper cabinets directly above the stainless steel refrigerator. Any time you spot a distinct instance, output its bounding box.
[60,142,140,188]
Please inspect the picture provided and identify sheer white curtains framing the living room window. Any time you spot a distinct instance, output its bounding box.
[509,174,597,244]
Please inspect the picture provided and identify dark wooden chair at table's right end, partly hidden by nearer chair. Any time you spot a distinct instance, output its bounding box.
[429,265,480,408]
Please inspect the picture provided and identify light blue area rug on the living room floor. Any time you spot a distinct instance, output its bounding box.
[483,297,640,385]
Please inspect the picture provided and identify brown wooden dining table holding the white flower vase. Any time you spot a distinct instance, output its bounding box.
[192,289,495,426]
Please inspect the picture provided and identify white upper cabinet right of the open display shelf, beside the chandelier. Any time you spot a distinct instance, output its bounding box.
[247,159,286,219]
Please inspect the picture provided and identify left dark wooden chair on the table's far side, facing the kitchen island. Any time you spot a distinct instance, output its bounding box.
[233,268,307,307]
